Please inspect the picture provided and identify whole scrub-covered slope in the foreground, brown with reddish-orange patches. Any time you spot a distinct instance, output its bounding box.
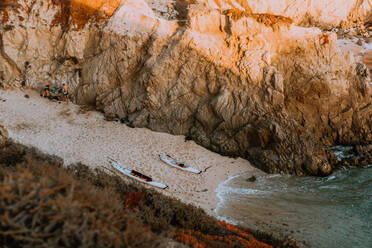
[0,137,296,247]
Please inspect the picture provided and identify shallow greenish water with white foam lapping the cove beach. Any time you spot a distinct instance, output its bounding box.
[216,166,372,248]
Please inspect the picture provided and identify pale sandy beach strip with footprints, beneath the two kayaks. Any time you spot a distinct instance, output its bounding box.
[0,90,262,214]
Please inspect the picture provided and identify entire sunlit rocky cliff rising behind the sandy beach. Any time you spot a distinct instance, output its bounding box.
[0,0,372,175]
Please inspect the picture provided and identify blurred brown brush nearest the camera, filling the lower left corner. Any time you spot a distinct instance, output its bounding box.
[0,142,162,247]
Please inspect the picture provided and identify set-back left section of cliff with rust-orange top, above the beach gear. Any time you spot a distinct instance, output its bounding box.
[0,0,121,89]
